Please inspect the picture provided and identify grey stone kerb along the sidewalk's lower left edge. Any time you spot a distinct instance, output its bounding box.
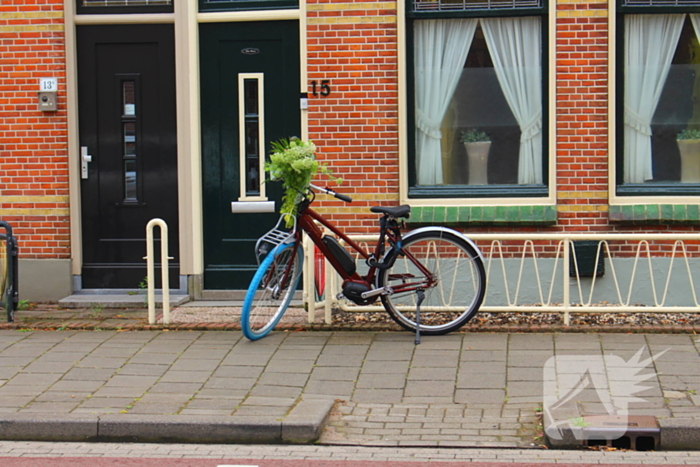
[0,398,334,444]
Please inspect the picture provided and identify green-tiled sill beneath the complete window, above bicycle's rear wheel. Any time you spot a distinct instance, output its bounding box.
[408,205,557,225]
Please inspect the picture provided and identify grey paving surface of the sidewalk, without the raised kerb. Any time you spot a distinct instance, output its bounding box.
[0,311,700,448]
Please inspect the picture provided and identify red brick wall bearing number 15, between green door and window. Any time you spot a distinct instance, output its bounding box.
[307,0,399,230]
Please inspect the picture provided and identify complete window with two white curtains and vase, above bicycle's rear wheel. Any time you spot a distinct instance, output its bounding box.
[409,0,547,197]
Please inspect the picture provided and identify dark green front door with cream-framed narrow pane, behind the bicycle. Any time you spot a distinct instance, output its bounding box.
[200,21,301,290]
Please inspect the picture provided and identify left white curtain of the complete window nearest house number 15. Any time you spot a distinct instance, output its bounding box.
[414,19,478,185]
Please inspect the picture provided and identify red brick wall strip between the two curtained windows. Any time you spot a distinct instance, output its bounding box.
[555,0,611,231]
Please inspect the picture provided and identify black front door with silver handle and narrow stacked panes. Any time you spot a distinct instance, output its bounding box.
[77,25,179,288]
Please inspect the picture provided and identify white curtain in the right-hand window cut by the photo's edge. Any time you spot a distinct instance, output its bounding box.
[624,14,685,183]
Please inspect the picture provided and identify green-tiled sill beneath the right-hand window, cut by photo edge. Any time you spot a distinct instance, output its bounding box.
[608,204,700,224]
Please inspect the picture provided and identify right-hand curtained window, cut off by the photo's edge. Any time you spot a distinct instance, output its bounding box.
[617,0,700,195]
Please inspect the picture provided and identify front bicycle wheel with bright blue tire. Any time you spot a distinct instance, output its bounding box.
[241,244,303,341]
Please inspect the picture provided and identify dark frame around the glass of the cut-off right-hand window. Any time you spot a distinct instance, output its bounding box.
[611,0,700,197]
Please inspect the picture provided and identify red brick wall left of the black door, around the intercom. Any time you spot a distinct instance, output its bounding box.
[0,0,70,258]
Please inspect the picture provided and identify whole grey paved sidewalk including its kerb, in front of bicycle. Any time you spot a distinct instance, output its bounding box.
[0,322,700,449]
